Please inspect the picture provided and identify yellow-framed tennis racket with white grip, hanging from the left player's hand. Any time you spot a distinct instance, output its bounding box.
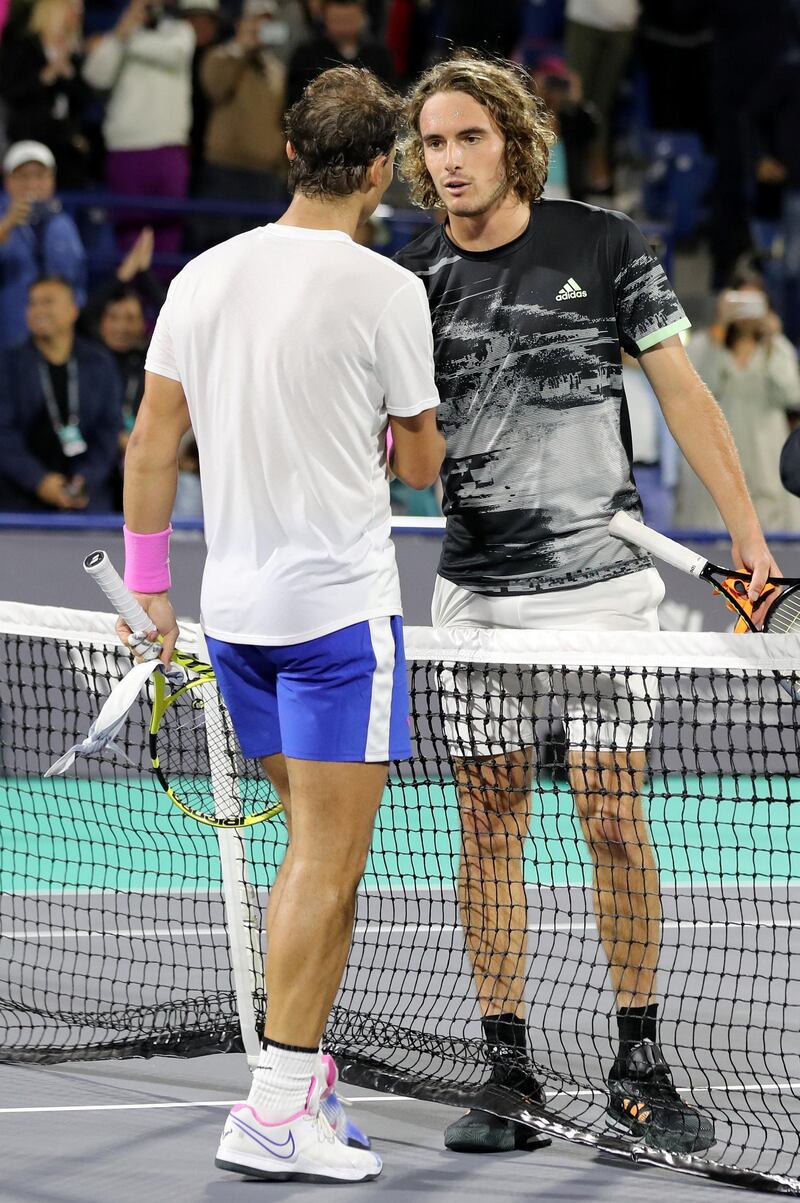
[83,551,283,828]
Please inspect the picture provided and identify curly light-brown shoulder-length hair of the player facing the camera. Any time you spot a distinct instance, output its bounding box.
[399,51,556,209]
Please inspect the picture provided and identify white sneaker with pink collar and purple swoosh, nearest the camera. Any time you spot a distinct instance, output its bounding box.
[214,1079,383,1183]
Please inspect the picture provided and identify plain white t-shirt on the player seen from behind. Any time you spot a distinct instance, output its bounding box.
[146,225,439,645]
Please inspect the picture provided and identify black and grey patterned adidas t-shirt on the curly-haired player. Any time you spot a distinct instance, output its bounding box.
[397,201,689,594]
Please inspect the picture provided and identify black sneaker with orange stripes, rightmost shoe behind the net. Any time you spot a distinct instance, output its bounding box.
[606,1041,715,1154]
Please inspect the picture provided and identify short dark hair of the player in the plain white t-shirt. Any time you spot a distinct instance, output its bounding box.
[286,67,403,197]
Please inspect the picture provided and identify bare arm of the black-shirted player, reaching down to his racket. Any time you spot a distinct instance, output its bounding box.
[639,336,778,602]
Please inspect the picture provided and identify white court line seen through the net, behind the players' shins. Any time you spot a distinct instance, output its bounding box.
[0,917,800,943]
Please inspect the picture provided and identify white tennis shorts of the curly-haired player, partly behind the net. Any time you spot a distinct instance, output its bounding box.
[432,568,664,759]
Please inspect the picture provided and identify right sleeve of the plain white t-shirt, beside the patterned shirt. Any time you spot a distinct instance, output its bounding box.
[375,279,439,417]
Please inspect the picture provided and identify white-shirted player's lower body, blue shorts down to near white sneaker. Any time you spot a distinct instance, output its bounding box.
[209,620,401,1181]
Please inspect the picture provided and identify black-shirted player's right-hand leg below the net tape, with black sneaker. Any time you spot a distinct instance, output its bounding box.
[568,678,713,1152]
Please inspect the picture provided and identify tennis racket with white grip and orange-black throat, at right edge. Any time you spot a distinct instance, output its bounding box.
[609,510,800,634]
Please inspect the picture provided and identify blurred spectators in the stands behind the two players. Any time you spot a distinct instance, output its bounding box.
[0,0,800,531]
